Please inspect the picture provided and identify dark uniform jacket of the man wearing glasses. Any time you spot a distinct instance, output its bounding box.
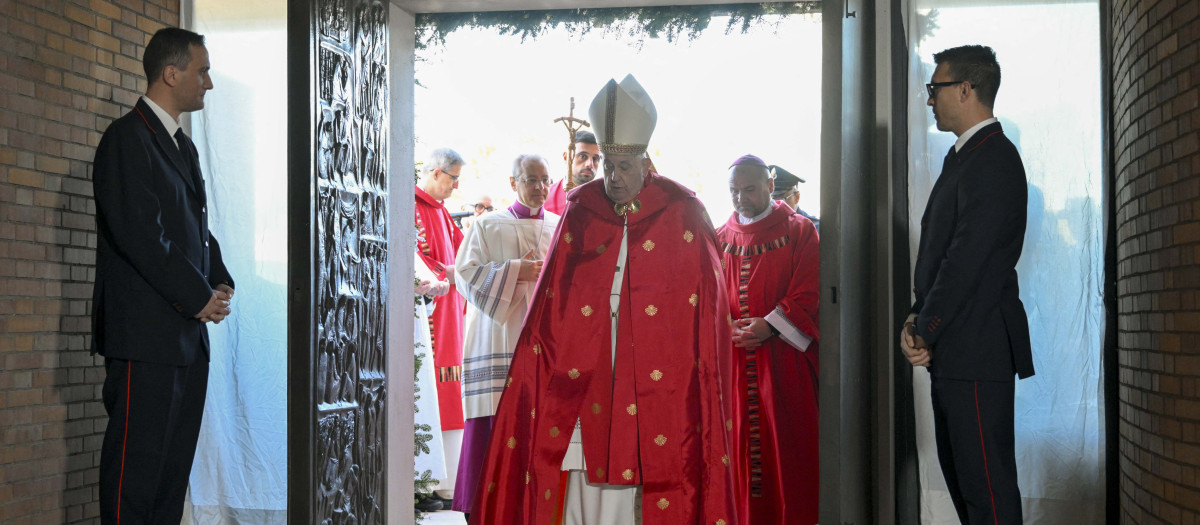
[912,122,1033,381]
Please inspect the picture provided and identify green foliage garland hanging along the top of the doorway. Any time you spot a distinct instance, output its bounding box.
[416,1,821,49]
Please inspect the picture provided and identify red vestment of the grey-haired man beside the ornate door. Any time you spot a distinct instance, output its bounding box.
[415,188,464,430]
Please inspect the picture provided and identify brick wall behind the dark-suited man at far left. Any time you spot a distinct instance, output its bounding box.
[0,0,179,525]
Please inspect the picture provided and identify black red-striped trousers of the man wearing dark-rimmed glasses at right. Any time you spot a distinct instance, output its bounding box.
[930,376,1021,525]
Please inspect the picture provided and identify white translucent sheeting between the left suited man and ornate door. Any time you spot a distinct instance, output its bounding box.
[188,0,288,524]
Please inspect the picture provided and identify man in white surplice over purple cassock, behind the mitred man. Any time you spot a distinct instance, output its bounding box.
[451,155,558,513]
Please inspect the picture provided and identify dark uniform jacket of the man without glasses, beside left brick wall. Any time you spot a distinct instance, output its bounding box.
[91,99,233,366]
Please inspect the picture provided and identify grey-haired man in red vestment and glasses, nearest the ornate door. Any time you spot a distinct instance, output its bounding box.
[414,150,464,430]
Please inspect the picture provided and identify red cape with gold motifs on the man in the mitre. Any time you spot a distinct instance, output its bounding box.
[470,174,737,525]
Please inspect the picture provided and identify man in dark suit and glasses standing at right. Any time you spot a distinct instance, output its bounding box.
[900,46,1033,524]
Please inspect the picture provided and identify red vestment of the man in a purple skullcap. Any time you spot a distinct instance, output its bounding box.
[716,201,820,525]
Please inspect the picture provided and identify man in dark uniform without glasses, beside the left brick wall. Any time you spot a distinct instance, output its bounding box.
[92,28,233,525]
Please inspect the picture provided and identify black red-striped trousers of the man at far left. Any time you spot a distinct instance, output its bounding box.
[100,358,209,525]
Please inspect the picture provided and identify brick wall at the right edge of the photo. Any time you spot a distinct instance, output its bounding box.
[1109,0,1200,524]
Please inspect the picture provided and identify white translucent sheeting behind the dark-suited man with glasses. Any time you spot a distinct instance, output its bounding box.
[907,0,1105,524]
